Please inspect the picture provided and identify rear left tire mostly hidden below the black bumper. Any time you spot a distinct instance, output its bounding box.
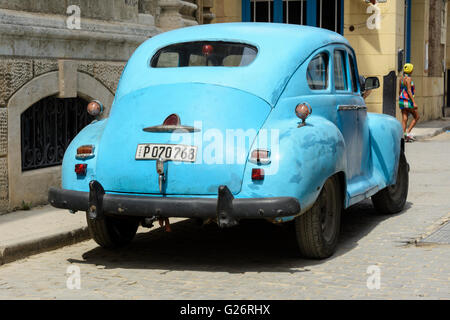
[86,213,139,248]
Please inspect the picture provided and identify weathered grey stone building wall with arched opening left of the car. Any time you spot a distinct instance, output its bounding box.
[0,0,214,213]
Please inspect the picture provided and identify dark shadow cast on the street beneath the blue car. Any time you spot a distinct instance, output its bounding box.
[68,201,411,273]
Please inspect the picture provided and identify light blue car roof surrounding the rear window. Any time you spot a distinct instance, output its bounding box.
[116,22,349,106]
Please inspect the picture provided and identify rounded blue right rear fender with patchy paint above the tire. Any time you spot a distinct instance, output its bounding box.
[239,115,347,218]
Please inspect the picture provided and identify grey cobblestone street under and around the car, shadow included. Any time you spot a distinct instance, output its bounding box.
[0,133,450,299]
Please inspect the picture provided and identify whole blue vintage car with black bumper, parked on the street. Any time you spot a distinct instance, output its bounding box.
[49,23,409,259]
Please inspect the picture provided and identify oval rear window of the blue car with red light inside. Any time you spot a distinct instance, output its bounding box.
[150,41,258,68]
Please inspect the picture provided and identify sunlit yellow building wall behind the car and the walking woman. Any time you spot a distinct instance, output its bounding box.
[214,0,450,121]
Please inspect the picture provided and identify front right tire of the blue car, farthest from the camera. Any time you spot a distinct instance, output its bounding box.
[372,151,409,214]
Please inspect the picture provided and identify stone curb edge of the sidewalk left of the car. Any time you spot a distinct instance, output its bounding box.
[0,226,90,265]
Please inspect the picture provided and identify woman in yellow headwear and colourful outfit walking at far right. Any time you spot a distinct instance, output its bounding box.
[399,63,420,142]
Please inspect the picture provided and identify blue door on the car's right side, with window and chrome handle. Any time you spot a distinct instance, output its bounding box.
[332,46,366,184]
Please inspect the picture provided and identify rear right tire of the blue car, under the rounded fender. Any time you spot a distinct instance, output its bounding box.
[295,176,342,259]
